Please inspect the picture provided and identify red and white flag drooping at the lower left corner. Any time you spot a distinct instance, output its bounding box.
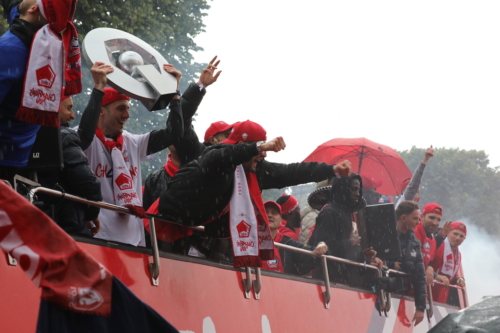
[0,182,112,316]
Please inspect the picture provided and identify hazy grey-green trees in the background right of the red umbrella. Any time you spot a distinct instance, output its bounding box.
[399,147,500,236]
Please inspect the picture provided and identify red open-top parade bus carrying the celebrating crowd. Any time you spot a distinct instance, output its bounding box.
[0,187,468,333]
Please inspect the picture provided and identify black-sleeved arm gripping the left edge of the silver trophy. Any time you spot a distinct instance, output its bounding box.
[78,62,114,150]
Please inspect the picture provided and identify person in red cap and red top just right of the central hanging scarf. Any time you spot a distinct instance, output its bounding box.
[262,201,328,274]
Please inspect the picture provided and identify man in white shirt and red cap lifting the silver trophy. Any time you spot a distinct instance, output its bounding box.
[78,65,183,246]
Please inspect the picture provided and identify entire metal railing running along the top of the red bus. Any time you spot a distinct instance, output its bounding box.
[3,187,468,312]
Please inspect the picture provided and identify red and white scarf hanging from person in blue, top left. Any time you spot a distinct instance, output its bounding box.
[16,0,82,127]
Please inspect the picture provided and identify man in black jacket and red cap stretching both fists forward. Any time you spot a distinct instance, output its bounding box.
[159,120,350,238]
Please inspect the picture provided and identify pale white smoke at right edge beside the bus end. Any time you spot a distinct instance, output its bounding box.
[459,219,500,305]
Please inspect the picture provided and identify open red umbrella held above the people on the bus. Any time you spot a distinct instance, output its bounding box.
[304,138,412,195]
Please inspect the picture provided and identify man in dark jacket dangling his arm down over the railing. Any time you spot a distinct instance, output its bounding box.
[387,201,427,326]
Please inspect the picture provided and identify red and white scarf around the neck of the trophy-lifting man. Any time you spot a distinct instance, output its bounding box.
[95,128,146,218]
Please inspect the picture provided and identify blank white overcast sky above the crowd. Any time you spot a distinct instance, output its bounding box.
[195,0,500,166]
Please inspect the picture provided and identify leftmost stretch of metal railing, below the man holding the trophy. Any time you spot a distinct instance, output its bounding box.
[29,187,204,286]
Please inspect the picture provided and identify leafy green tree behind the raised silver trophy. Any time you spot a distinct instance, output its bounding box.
[0,0,210,180]
